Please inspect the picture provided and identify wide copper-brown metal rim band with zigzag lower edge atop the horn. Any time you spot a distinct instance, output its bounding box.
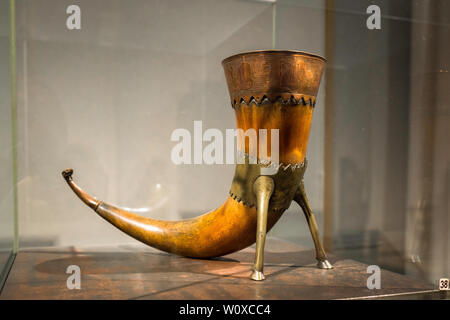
[222,50,326,105]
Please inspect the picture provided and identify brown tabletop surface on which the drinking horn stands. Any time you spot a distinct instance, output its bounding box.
[0,238,435,299]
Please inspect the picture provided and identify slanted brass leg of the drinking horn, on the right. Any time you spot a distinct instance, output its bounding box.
[294,181,333,269]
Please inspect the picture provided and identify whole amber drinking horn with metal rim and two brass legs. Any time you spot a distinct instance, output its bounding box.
[62,50,332,280]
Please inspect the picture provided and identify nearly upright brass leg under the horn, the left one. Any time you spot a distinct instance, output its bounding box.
[251,176,274,281]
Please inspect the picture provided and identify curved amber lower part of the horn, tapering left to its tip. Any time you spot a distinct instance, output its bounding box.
[63,169,281,258]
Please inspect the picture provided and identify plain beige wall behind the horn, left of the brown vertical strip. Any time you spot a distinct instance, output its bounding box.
[17,0,325,247]
